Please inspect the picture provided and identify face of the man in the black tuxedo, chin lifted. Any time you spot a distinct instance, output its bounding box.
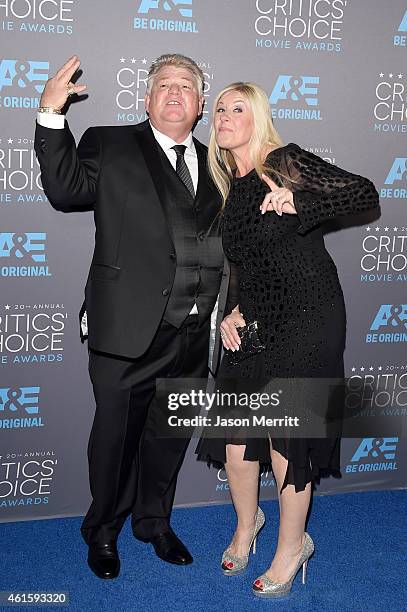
[145,66,203,134]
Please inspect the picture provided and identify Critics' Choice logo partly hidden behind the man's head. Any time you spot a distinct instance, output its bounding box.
[115,57,214,125]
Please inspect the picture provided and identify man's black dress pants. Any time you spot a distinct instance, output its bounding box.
[81,315,210,544]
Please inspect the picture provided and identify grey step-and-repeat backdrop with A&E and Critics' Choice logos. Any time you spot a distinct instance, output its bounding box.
[0,0,407,521]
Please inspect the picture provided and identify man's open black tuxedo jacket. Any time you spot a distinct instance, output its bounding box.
[35,121,227,365]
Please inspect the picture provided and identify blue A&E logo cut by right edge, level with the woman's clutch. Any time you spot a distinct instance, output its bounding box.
[366,304,407,344]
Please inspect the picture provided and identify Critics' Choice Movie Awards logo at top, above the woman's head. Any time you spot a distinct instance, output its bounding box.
[254,0,347,53]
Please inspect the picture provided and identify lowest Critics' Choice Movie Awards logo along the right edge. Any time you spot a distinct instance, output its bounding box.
[345,364,407,417]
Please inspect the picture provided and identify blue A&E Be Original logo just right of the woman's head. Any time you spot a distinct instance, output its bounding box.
[269,74,322,121]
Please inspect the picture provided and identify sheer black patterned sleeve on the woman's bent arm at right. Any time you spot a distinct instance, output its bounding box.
[285,143,379,234]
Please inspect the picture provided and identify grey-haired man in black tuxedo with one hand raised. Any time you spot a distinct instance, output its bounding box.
[35,54,224,578]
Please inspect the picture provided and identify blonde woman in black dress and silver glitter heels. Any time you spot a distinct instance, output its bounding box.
[197,83,378,597]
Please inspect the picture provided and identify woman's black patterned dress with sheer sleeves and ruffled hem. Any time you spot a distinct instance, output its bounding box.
[196,143,379,491]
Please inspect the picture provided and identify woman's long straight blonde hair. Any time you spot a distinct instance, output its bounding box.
[208,82,283,203]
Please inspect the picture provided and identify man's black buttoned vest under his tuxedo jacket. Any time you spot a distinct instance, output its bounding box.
[157,144,224,327]
